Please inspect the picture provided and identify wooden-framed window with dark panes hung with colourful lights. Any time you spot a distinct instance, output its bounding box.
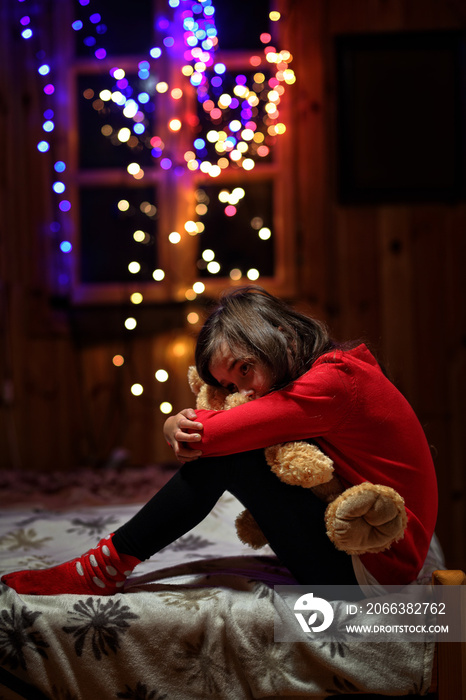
[62,0,294,304]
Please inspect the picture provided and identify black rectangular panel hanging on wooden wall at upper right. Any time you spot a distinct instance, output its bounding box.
[336,32,465,203]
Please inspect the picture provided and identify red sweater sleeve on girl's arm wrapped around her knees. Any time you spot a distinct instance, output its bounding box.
[192,360,355,457]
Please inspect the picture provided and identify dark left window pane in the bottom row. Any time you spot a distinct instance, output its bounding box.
[80,187,158,283]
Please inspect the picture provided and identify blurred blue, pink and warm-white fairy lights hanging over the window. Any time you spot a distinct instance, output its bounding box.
[18,0,296,413]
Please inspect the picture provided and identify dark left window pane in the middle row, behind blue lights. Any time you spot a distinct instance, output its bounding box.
[77,74,155,168]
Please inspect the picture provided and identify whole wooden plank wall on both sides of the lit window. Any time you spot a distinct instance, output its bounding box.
[0,0,466,567]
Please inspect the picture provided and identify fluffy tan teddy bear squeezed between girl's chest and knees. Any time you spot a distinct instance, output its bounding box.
[188,367,408,555]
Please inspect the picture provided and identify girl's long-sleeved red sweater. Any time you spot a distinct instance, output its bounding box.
[196,345,437,585]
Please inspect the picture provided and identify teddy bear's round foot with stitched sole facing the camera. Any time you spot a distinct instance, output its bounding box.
[325,482,408,554]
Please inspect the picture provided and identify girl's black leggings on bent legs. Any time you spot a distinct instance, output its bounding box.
[113,450,357,585]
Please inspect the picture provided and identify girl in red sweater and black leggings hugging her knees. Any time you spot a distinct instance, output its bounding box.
[2,287,437,595]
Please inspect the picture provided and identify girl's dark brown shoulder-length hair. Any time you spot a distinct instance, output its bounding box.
[195,286,336,389]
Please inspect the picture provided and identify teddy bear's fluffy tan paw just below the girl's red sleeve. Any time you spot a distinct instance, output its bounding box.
[265,441,333,489]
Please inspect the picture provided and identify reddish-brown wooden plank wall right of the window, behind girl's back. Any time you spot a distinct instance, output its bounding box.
[290,0,466,567]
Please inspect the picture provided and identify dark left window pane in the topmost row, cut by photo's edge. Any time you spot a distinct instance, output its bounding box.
[74,0,152,57]
